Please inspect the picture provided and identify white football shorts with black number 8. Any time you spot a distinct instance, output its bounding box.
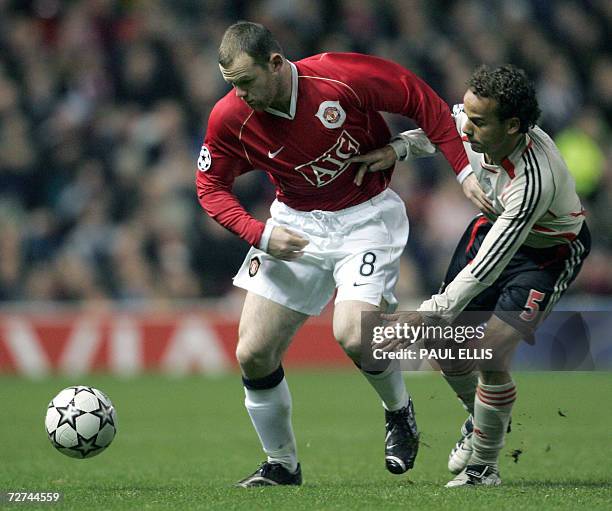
[234,189,409,316]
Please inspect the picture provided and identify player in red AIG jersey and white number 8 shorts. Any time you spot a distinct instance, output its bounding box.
[196,22,484,487]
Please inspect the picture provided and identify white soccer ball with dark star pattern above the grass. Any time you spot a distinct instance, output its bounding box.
[45,385,117,458]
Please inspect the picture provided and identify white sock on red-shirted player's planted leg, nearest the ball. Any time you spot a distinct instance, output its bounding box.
[244,378,297,472]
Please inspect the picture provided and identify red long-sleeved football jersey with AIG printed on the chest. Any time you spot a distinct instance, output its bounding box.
[196,53,469,246]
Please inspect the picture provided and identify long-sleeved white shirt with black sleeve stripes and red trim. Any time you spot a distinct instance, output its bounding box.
[392,105,584,322]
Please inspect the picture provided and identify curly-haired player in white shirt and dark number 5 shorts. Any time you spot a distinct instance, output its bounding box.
[353,65,590,487]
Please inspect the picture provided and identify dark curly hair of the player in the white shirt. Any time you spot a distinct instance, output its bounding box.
[467,64,541,133]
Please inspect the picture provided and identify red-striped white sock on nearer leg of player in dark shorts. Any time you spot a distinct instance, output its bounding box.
[470,381,516,468]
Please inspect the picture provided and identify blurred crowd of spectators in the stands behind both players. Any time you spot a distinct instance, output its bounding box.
[0,0,612,304]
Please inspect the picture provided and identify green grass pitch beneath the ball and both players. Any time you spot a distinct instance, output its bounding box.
[0,371,612,511]
